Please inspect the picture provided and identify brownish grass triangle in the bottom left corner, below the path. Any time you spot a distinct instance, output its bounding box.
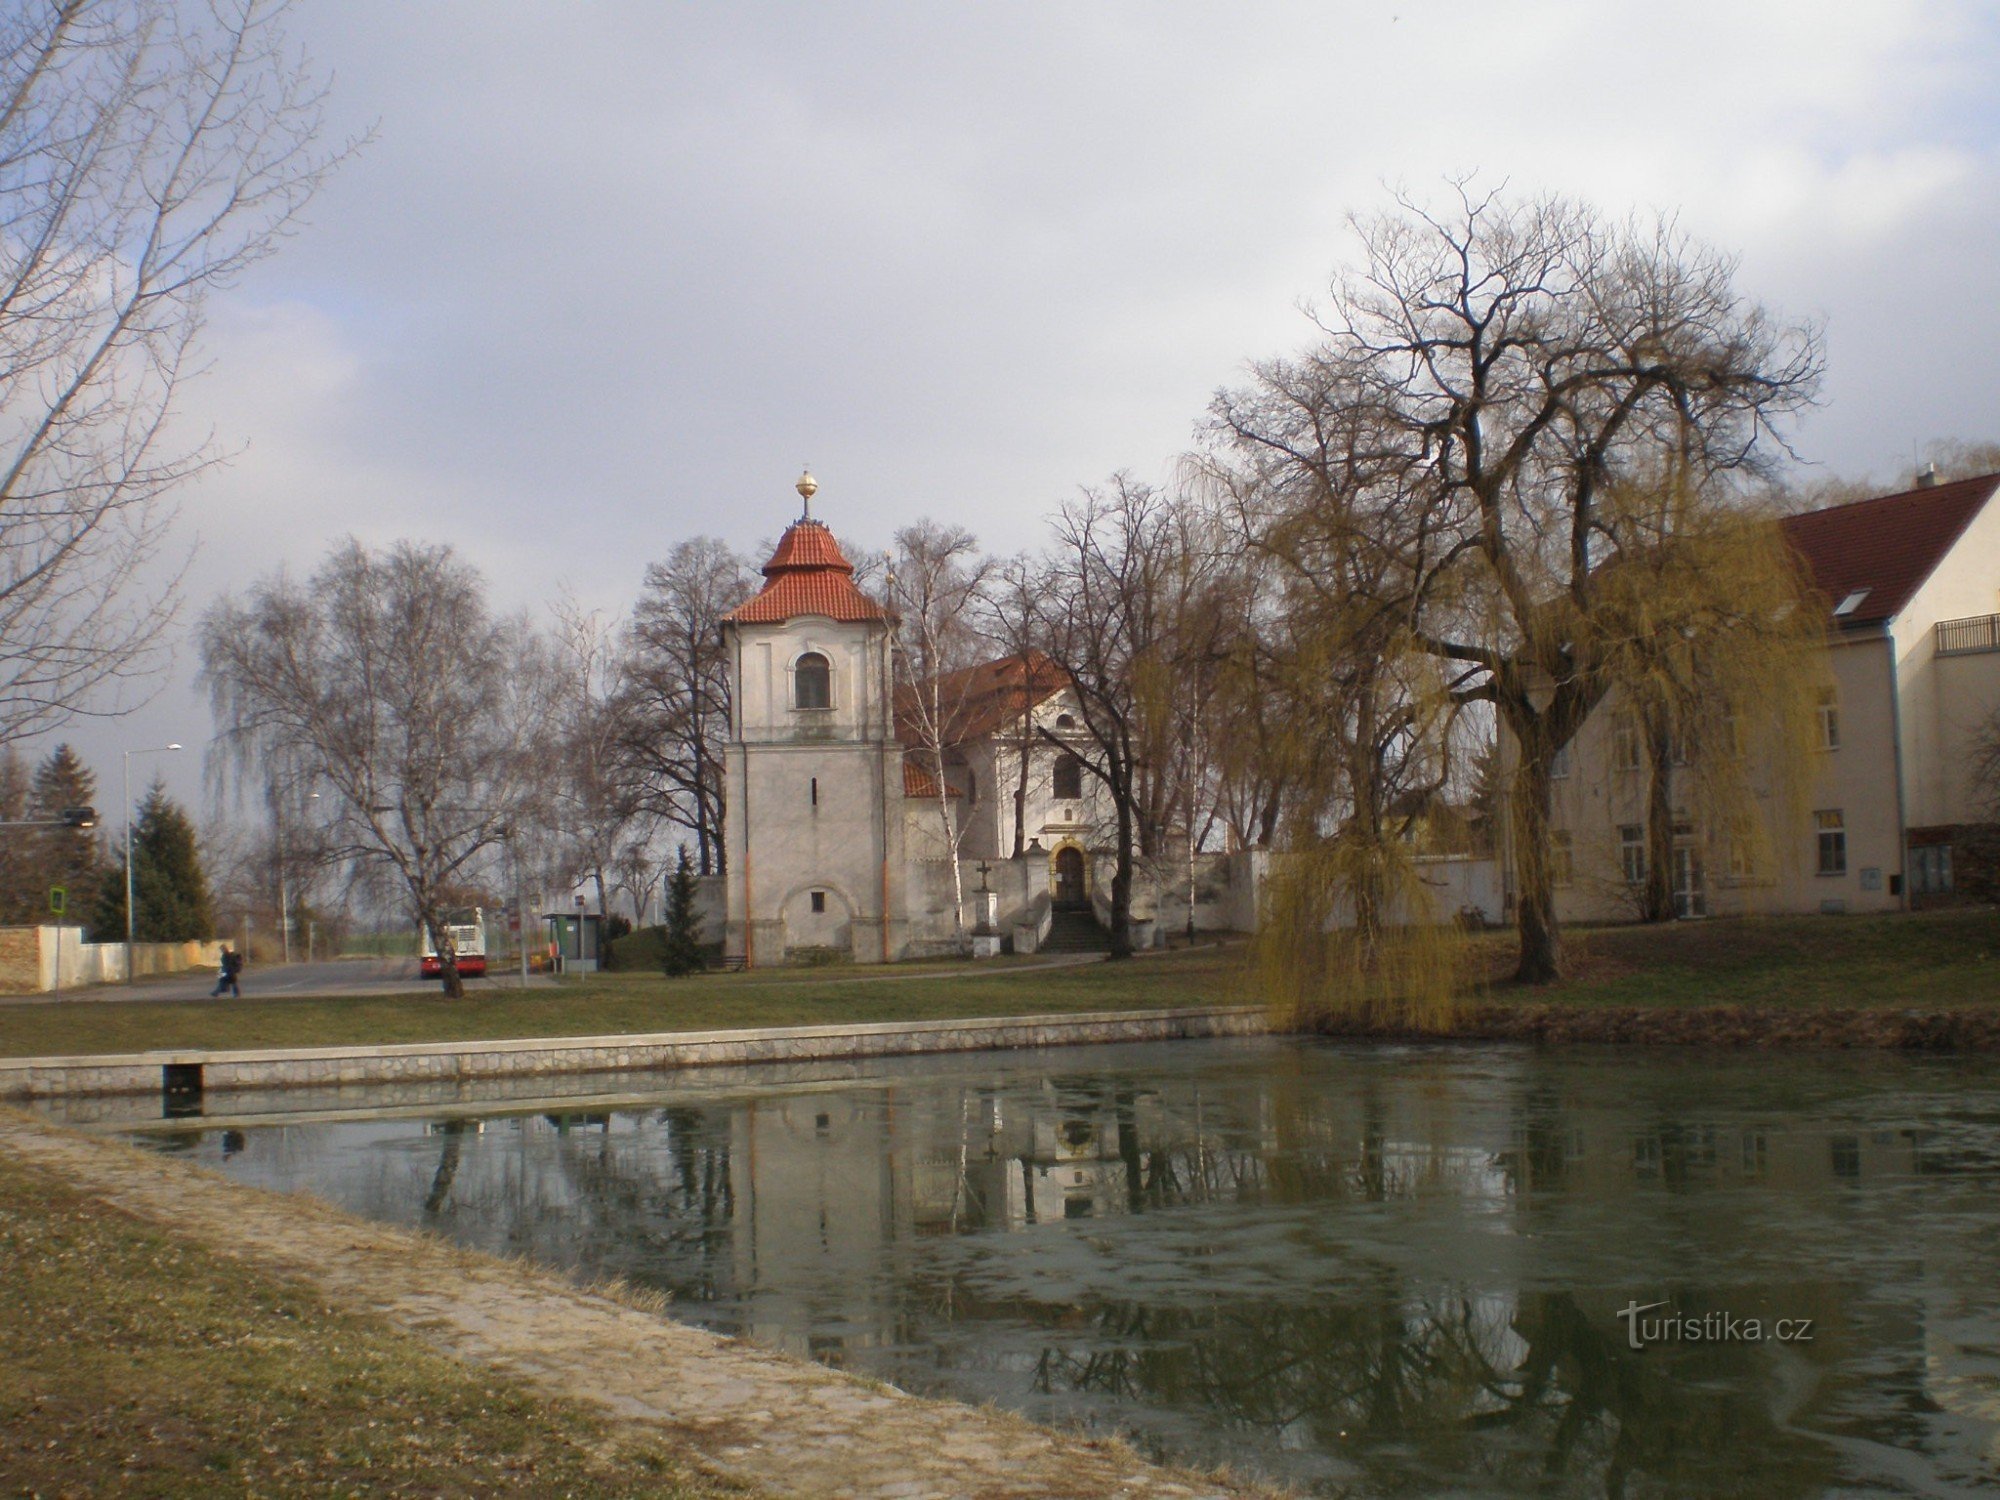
[0,1160,740,1496]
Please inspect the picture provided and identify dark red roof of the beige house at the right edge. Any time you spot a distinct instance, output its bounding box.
[1780,474,2000,628]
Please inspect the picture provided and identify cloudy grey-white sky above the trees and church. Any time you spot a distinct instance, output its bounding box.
[28,0,2000,824]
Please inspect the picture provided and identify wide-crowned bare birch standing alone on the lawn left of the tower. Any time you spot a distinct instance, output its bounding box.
[200,540,556,998]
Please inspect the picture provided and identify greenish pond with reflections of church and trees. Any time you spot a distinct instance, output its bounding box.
[137,1040,2000,1496]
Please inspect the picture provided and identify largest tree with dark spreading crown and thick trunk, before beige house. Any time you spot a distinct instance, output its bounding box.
[1260,184,1820,982]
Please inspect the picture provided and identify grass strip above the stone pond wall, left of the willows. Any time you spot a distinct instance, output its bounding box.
[0,948,1248,1058]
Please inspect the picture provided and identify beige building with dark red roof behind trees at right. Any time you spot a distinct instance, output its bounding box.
[1506,474,2000,922]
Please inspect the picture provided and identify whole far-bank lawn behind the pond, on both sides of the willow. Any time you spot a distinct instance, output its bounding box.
[0,910,2000,1056]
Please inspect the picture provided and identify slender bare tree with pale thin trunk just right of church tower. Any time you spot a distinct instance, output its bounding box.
[888,518,992,942]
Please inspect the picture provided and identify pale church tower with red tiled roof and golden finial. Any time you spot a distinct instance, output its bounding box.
[722,474,908,966]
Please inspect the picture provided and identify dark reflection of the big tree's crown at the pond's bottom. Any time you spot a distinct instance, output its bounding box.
[1034,1296,1832,1496]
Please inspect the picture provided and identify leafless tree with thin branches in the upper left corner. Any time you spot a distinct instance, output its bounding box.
[0,0,340,740]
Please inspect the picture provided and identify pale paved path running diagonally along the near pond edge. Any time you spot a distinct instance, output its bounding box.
[0,1114,1258,1500]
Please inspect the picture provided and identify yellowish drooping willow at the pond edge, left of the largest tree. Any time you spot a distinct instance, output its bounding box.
[1204,384,1460,1026]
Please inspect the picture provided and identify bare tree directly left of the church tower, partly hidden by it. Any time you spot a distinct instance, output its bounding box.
[622,536,752,874]
